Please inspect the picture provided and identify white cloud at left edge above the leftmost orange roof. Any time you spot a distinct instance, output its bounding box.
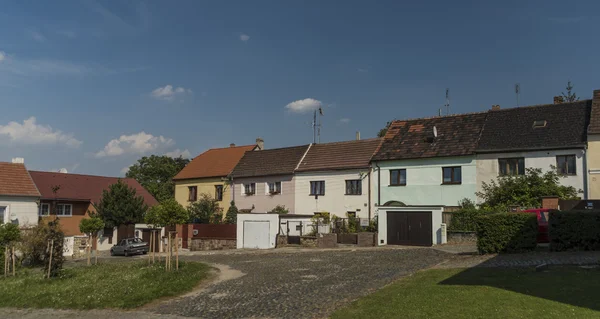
[0,116,83,147]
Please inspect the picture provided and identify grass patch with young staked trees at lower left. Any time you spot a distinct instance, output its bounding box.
[0,262,210,309]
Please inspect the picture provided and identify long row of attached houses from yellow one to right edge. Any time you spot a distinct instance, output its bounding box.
[174,90,600,224]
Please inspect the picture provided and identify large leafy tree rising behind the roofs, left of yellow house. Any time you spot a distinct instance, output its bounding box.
[125,155,190,202]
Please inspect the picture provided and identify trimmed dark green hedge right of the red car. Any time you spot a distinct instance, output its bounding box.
[548,211,600,251]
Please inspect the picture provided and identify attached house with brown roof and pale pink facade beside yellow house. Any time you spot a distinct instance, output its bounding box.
[230,145,310,214]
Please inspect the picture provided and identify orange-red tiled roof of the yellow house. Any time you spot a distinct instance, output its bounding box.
[173,145,256,180]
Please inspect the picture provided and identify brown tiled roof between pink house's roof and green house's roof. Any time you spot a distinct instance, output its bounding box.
[296,138,382,172]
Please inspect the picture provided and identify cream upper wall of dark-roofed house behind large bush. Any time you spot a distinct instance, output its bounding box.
[477,149,586,201]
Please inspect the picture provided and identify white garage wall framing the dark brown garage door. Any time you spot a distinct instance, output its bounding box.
[377,207,443,246]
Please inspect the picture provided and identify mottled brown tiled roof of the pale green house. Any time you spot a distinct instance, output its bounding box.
[373,113,486,161]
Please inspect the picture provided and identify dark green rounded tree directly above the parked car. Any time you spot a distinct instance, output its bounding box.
[94,180,148,227]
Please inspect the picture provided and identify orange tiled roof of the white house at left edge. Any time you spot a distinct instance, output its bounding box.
[0,162,40,197]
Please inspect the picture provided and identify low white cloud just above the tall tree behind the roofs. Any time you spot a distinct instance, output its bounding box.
[95,132,175,157]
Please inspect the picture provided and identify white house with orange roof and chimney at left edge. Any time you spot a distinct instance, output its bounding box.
[0,158,40,228]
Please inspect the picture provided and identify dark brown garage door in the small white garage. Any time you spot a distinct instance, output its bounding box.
[387,212,433,246]
